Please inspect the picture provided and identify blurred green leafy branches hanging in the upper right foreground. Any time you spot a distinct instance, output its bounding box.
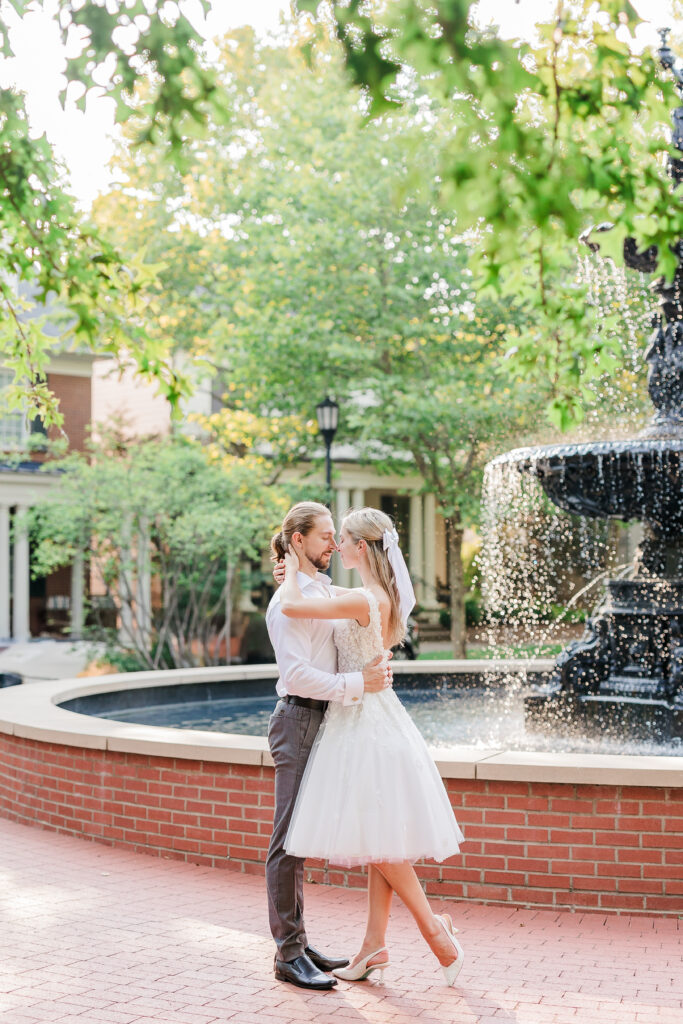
[298,0,683,429]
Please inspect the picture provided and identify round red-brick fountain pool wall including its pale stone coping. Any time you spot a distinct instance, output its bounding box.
[0,662,683,915]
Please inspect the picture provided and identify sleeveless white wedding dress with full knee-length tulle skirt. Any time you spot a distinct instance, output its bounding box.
[285,588,463,867]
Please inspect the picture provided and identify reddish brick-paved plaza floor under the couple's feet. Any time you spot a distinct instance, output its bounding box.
[0,819,683,1024]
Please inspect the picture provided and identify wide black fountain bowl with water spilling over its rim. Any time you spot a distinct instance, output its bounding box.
[490,437,683,539]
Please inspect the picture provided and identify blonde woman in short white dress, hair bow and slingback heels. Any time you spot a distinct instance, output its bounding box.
[280,508,464,985]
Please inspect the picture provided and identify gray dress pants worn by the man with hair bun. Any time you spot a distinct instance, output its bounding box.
[265,700,324,961]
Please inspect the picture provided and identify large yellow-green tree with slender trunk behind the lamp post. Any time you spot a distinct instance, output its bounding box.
[98,32,545,654]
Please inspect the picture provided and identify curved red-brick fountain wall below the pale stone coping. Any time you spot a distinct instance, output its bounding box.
[0,734,683,915]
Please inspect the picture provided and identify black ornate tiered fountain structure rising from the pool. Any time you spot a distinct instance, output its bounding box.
[495,30,683,739]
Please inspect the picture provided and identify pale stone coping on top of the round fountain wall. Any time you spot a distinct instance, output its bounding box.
[0,659,683,787]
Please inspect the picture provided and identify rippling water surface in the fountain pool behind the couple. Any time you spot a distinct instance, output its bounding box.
[59,660,683,767]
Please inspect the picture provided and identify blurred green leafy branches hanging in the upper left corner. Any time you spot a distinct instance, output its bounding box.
[0,0,227,424]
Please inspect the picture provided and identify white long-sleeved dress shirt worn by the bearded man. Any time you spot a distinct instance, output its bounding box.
[265,571,364,705]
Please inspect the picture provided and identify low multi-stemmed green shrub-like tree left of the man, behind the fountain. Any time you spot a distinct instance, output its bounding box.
[31,433,289,669]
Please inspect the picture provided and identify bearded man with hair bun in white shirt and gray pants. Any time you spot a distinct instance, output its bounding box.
[265,502,391,989]
